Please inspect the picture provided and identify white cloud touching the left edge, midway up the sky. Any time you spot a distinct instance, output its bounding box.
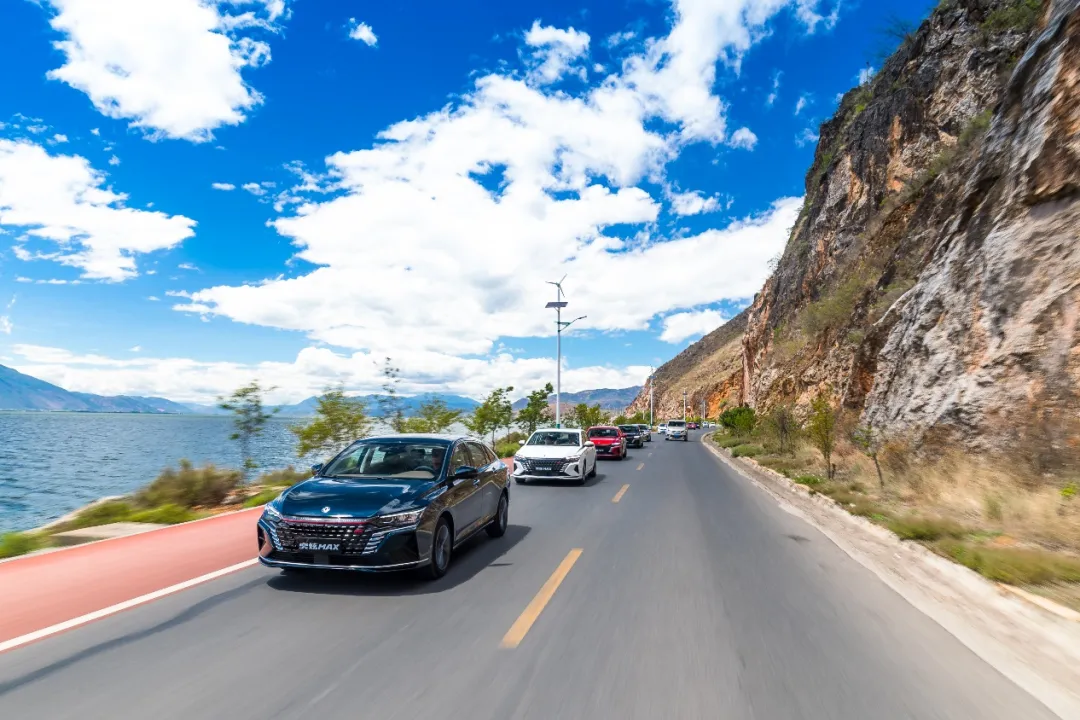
[0,139,195,281]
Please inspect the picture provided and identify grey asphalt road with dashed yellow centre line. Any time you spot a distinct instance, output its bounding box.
[0,437,1054,720]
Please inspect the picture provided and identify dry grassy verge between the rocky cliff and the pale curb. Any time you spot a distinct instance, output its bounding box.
[721,438,1080,609]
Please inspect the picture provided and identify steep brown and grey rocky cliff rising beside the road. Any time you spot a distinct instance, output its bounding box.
[635,0,1080,445]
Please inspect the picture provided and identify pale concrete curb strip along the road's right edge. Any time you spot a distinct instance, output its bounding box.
[702,436,1080,720]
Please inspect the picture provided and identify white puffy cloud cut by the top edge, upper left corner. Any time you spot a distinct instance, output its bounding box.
[43,0,285,141]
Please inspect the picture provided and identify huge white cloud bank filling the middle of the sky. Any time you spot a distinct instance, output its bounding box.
[168,0,801,357]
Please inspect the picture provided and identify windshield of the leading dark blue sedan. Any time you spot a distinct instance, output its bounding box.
[322,439,447,479]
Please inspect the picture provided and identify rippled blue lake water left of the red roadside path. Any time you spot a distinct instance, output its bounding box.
[0,411,447,532]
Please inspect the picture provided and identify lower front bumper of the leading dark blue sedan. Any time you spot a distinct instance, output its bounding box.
[257,518,431,572]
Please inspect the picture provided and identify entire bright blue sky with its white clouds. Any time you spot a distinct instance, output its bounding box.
[0,0,932,400]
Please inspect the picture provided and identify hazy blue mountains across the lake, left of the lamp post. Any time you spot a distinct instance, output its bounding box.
[0,365,480,417]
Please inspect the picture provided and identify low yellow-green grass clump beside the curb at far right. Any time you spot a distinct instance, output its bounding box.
[935,541,1080,585]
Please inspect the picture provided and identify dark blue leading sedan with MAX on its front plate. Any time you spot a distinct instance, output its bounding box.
[258,434,510,579]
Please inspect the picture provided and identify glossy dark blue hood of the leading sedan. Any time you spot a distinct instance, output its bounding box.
[278,477,434,517]
